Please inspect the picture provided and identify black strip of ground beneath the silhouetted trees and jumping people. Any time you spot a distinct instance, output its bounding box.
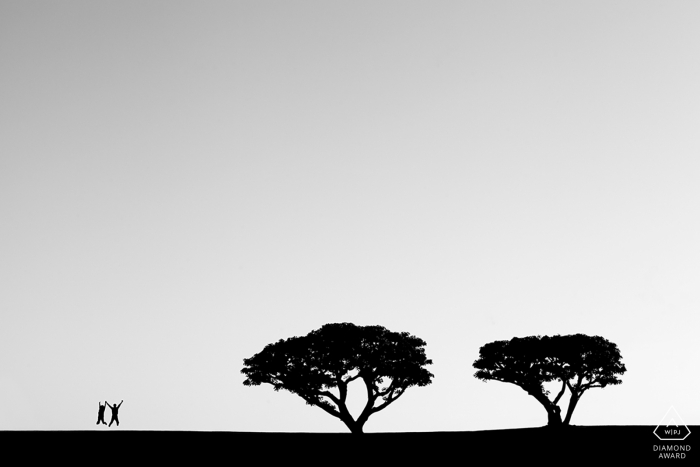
[0,426,700,466]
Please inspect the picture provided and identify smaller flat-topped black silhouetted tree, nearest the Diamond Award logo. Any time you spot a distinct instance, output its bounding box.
[474,334,626,426]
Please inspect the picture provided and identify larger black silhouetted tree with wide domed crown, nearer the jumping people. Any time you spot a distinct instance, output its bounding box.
[241,323,433,434]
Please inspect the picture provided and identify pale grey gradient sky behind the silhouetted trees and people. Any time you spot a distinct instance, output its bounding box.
[0,0,700,432]
